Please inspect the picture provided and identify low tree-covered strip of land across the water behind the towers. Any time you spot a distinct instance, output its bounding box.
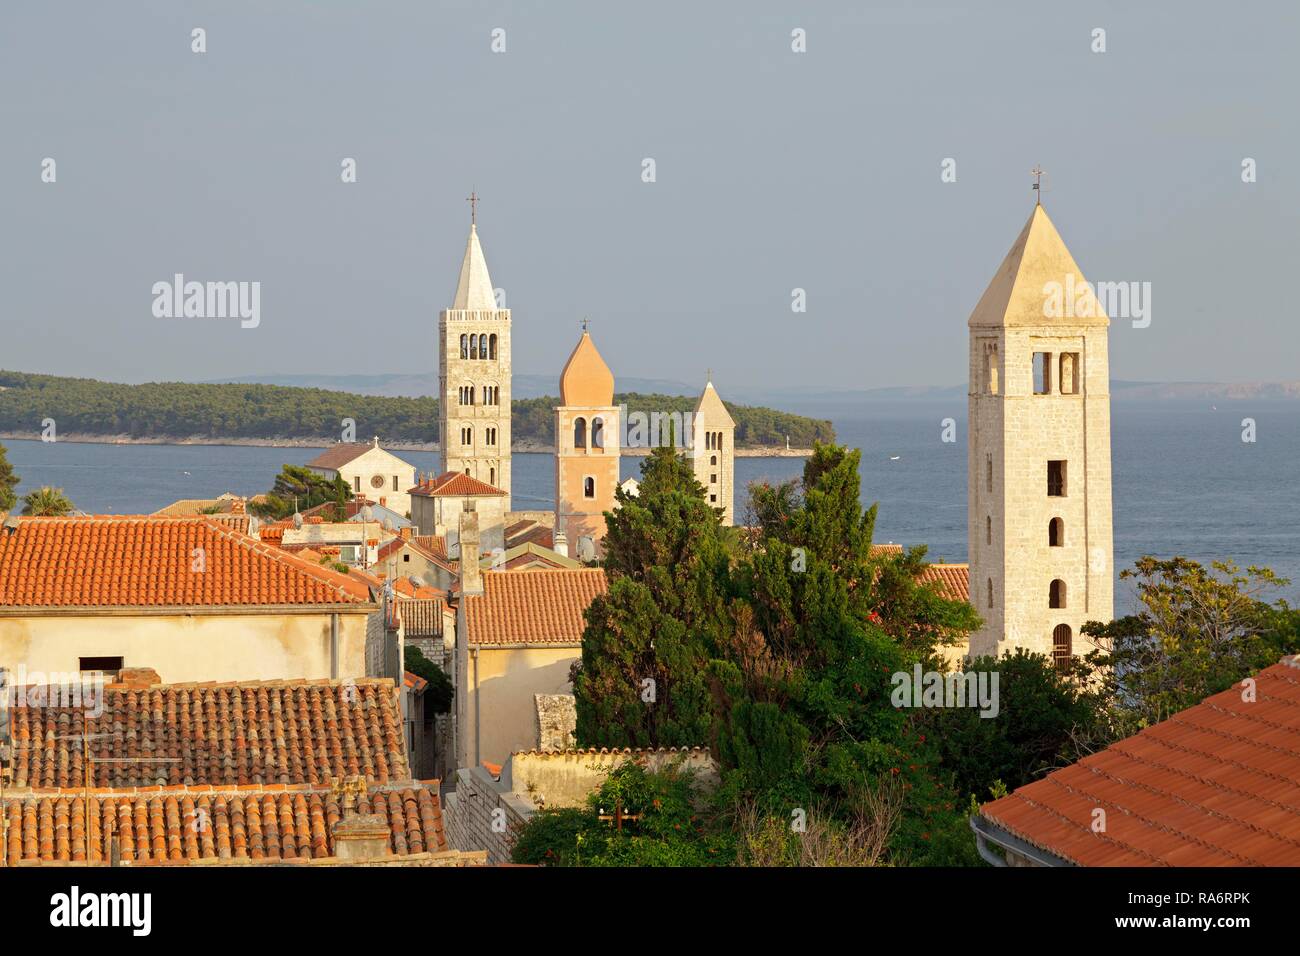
[0,371,835,447]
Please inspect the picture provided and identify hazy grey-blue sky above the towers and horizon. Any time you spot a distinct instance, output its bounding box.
[0,0,1300,390]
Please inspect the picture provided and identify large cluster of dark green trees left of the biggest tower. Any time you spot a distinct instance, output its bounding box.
[573,445,978,864]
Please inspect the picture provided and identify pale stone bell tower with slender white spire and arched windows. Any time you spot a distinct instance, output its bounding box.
[438,209,511,511]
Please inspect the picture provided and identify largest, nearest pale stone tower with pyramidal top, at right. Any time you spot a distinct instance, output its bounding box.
[967,206,1114,663]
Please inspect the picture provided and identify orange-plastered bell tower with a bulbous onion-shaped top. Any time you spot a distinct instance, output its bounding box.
[555,329,621,561]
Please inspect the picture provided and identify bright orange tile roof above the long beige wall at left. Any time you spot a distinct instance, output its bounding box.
[0,515,369,607]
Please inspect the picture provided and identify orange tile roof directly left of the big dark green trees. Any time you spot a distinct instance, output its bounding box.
[462,567,607,644]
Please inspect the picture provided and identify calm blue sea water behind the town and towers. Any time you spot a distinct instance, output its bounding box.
[4,403,1300,610]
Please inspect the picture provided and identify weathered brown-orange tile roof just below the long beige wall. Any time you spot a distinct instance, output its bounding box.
[9,678,411,788]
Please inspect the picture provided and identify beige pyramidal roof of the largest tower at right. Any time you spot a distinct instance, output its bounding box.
[967,206,1110,328]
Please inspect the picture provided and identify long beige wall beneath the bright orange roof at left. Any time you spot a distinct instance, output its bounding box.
[0,607,378,684]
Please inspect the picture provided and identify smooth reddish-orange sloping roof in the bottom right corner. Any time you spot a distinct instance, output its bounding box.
[980,657,1300,866]
